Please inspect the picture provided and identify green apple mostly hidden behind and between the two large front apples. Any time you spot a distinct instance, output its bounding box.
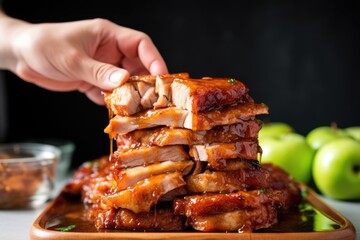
[306,126,349,150]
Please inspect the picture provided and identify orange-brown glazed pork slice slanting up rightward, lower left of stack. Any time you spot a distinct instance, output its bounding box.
[103,172,186,213]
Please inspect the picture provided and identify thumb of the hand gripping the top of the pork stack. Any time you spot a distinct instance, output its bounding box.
[80,58,130,90]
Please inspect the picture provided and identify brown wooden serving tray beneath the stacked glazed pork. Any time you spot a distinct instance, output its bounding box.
[30,186,356,240]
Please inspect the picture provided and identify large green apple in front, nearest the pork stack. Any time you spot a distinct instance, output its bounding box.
[259,132,314,183]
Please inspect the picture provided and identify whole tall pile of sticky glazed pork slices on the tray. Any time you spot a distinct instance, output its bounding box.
[64,73,301,232]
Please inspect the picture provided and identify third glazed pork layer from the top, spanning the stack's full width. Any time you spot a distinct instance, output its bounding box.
[116,120,261,149]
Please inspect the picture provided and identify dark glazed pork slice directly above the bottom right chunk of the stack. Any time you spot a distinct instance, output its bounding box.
[185,163,271,193]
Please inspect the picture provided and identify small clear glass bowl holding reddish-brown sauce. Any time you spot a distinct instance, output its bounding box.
[0,143,60,209]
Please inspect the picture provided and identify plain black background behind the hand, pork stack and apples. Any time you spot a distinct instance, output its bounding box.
[3,0,360,166]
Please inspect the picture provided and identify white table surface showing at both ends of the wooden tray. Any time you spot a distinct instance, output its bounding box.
[0,183,360,240]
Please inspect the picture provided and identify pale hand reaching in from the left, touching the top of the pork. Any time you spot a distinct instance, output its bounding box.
[0,8,168,105]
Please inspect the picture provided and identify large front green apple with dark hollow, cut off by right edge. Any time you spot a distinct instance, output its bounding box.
[313,138,360,200]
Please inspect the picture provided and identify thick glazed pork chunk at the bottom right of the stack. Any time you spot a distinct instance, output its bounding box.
[174,190,280,232]
